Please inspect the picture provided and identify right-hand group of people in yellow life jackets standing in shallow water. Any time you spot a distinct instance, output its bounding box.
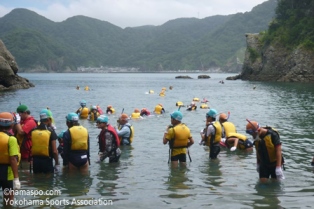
[163,109,285,182]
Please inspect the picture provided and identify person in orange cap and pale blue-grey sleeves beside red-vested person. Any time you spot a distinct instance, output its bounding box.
[116,113,134,145]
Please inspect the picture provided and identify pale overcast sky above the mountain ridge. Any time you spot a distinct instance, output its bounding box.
[0,0,267,28]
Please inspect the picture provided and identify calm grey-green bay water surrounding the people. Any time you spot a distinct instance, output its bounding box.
[0,74,314,209]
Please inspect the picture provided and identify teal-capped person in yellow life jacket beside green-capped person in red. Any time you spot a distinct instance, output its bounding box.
[31,109,60,173]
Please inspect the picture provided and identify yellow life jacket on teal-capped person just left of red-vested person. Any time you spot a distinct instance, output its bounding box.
[69,126,88,150]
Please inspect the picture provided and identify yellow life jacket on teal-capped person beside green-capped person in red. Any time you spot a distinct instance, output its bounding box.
[32,129,51,157]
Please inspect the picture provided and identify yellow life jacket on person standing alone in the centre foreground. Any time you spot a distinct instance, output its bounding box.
[169,123,190,149]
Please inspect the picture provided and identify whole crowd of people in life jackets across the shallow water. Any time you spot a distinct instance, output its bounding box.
[0,94,300,206]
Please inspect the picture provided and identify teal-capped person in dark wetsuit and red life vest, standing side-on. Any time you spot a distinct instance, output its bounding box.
[97,115,121,163]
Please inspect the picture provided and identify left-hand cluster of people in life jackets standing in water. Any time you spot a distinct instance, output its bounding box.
[0,100,134,204]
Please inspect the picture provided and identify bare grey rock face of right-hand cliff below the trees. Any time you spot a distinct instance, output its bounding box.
[227,34,314,82]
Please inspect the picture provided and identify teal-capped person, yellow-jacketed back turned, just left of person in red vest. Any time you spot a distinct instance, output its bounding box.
[63,112,90,172]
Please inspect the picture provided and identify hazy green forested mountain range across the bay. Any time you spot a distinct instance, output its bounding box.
[0,0,277,72]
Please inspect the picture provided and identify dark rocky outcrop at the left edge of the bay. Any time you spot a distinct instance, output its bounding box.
[0,40,34,91]
